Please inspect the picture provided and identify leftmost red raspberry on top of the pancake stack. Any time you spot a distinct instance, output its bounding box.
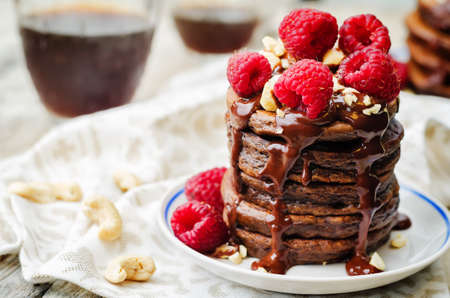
[227,52,272,97]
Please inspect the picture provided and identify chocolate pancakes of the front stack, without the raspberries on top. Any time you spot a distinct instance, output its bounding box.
[222,88,403,273]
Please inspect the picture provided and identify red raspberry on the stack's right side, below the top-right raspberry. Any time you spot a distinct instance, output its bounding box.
[337,48,400,101]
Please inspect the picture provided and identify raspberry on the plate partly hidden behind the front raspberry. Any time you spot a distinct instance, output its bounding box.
[184,168,227,214]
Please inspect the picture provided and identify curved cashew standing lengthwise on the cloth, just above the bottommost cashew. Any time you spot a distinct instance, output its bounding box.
[83,196,122,241]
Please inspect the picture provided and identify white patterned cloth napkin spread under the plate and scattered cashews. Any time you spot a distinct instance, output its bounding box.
[0,66,450,297]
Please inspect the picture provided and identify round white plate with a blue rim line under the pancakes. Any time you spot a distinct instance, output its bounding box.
[158,186,450,294]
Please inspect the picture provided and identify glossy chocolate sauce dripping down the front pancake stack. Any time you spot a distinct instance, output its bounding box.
[226,90,400,275]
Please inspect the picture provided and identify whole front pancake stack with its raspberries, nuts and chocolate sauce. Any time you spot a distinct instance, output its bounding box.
[222,9,405,275]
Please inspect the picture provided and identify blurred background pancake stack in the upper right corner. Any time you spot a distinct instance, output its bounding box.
[406,0,450,97]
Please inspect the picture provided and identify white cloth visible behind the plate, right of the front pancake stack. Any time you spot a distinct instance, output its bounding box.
[396,92,450,207]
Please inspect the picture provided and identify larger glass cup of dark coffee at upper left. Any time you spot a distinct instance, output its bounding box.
[16,0,157,117]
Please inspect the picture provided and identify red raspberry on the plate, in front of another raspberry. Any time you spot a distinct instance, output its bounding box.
[170,201,228,253]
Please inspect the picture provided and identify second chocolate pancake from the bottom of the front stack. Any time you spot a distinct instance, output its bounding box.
[227,193,398,239]
